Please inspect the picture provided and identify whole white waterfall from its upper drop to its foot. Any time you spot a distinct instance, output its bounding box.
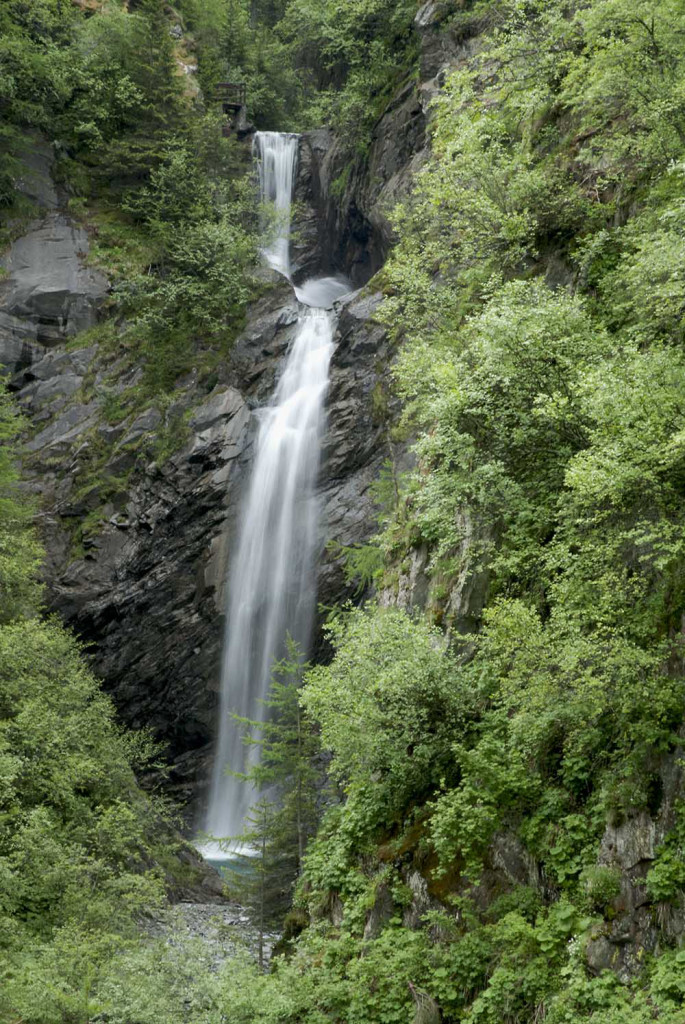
[201,132,349,857]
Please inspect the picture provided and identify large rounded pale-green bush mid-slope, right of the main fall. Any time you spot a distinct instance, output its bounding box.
[389,282,607,598]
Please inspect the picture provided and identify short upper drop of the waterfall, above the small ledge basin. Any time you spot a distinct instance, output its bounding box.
[253,131,299,280]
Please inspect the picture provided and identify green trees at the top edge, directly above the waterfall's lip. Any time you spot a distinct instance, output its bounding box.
[200,0,417,142]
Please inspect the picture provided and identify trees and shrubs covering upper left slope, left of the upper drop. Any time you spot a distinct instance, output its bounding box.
[0,0,256,395]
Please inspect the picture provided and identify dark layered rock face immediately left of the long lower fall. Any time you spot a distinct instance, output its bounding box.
[17,314,280,802]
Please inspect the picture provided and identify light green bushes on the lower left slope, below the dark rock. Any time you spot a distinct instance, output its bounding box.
[0,382,211,1024]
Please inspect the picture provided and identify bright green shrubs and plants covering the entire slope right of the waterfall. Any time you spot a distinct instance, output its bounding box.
[216,0,685,1024]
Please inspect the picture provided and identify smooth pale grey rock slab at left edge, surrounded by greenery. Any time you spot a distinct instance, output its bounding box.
[0,213,109,352]
